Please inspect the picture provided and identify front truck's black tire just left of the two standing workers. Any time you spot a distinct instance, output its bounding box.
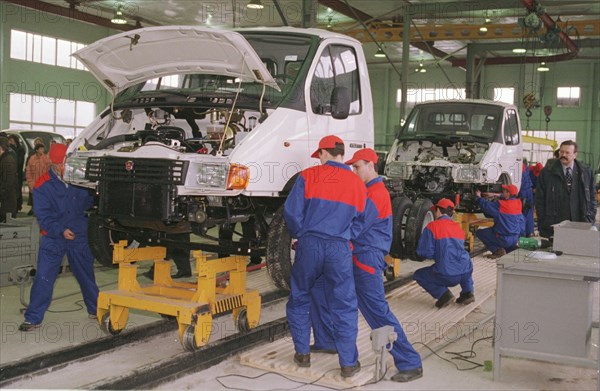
[266,205,295,291]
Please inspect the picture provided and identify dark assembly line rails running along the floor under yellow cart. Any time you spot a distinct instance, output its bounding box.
[0,276,412,389]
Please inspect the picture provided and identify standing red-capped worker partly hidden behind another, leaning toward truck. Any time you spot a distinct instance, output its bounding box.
[311,148,423,382]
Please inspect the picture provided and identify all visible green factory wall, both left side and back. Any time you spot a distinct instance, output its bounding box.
[0,2,600,167]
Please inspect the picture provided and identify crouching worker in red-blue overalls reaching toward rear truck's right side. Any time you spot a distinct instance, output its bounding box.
[475,185,525,259]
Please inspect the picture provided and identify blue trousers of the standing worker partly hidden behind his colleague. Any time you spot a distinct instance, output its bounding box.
[311,251,422,371]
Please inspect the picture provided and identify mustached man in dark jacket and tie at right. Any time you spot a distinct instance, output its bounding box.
[535,140,597,238]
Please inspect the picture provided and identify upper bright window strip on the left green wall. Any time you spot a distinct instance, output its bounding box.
[10,30,86,70]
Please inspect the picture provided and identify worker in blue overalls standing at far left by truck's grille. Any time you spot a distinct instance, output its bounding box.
[19,143,98,331]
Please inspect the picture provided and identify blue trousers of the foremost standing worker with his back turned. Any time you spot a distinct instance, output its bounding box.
[286,235,358,367]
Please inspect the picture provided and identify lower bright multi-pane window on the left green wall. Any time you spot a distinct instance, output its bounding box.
[9,94,96,138]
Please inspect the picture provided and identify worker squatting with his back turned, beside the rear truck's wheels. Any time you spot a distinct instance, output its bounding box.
[413,198,475,308]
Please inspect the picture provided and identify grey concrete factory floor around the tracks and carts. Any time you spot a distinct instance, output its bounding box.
[0,202,600,391]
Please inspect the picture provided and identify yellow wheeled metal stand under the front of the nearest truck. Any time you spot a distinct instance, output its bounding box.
[97,240,261,351]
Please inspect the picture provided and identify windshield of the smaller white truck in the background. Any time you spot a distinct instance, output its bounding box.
[398,102,503,142]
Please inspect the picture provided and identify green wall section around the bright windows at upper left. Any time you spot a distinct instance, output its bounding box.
[0,2,117,129]
